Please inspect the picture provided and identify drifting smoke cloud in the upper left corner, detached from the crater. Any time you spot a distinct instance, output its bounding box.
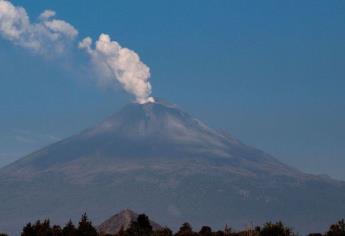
[0,0,78,55]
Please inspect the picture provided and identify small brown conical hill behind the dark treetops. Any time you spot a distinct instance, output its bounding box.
[97,209,162,234]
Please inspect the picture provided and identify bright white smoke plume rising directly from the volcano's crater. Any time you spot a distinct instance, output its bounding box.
[79,34,154,103]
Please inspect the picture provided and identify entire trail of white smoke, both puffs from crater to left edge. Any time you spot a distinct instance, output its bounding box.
[0,0,154,103]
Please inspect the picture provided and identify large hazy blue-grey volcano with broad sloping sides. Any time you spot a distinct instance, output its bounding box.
[0,100,345,234]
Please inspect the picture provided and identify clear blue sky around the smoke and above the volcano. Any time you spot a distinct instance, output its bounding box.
[0,0,345,180]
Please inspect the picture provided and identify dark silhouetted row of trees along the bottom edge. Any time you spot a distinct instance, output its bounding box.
[0,214,345,236]
